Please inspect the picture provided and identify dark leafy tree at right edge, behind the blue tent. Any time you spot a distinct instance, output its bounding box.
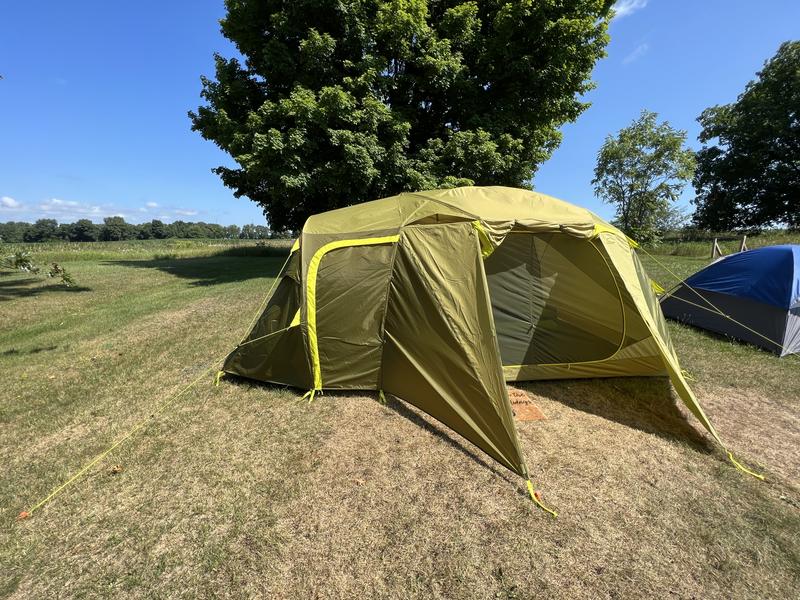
[694,41,800,231]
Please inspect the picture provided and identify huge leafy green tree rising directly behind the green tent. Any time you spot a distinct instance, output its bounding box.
[190,0,612,230]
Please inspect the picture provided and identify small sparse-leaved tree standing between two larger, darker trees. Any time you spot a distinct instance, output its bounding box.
[592,110,695,243]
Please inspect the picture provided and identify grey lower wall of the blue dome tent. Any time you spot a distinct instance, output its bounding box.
[661,285,789,354]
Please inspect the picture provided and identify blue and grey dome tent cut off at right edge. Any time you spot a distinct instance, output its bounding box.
[661,244,800,356]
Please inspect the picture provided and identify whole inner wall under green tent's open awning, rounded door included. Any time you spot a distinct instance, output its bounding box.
[494,231,666,381]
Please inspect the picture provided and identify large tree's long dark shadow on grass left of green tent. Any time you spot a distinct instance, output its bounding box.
[105,248,288,286]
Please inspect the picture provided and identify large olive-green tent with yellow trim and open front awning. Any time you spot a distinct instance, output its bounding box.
[223,187,721,488]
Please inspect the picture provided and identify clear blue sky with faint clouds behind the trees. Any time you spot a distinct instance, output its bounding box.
[0,0,800,224]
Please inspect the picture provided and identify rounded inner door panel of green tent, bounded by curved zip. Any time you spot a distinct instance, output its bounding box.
[485,232,625,365]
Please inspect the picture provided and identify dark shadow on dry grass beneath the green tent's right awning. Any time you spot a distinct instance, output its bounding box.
[519,377,714,453]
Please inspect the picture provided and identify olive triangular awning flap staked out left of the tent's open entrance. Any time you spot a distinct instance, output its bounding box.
[381,223,527,476]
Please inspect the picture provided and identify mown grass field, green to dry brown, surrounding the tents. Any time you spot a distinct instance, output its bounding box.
[0,242,800,599]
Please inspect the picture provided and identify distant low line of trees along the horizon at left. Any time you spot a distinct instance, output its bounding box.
[0,217,281,243]
